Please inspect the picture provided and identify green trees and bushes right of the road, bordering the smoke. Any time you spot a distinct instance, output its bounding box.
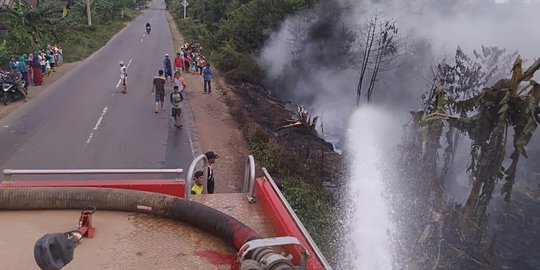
[165,0,317,83]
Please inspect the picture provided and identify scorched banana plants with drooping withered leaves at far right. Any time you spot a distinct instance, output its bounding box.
[414,55,540,240]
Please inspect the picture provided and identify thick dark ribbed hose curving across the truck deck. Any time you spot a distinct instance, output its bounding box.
[0,187,260,268]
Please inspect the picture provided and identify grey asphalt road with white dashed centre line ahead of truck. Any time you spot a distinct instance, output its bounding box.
[0,1,194,179]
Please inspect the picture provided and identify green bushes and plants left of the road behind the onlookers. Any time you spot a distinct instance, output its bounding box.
[0,0,147,65]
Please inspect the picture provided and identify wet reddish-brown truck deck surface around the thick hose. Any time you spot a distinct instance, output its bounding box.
[0,194,274,270]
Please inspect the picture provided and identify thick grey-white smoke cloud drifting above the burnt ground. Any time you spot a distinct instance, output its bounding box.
[259,0,540,148]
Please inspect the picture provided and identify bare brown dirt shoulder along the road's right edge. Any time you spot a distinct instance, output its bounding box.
[167,14,249,193]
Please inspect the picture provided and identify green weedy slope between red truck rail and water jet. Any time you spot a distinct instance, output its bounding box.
[225,92,340,261]
